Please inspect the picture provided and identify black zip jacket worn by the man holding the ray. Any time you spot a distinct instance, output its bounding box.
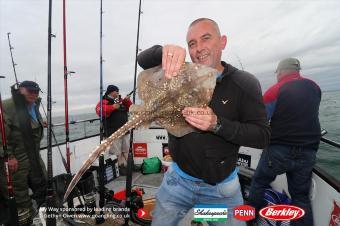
[137,45,270,184]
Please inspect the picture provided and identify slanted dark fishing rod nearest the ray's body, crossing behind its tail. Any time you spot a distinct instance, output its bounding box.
[124,0,142,226]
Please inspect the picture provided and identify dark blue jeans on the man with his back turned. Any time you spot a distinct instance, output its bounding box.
[249,145,316,226]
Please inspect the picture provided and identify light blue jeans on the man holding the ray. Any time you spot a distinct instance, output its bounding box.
[152,167,246,226]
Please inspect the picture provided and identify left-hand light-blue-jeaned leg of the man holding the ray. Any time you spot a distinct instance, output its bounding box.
[152,167,193,226]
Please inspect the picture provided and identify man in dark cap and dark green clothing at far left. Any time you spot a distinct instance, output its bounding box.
[0,81,47,222]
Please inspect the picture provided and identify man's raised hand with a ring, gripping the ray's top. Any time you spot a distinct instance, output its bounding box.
[162,45,186,79]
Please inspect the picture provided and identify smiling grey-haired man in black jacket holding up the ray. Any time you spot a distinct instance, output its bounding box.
[137,18,270,225]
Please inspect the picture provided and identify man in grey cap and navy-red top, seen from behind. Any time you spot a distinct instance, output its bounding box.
[249,58,321,226]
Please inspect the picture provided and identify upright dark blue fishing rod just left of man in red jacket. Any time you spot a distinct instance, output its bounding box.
[96,0,105,224]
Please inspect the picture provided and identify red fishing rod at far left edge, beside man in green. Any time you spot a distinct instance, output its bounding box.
[0,76,19,226]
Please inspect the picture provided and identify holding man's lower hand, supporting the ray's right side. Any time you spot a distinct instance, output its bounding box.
[182,107,217,131]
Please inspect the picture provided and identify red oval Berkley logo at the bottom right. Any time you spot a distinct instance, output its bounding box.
[259,205,305,221]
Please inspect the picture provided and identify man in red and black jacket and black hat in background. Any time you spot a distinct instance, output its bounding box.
[96,85,132,171]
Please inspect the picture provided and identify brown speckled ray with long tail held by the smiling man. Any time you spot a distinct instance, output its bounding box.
[64,63,217,200]
